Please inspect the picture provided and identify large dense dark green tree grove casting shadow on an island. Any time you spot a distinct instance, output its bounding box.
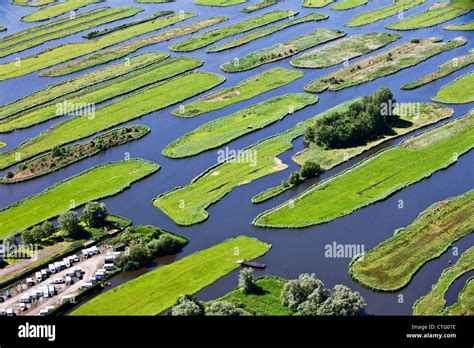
[305,87,395,149]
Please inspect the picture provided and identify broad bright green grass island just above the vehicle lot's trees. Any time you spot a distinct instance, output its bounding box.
[0,159,160,238]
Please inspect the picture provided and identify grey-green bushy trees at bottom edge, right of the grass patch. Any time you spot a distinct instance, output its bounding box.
[281,273,366,316]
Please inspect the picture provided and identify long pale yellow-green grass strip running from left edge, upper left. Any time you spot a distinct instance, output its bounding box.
[0,11,196,81]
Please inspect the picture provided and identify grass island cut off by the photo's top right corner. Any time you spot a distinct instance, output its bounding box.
[386,0,474,30]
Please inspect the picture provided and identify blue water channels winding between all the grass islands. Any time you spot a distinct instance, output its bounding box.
[0,0,474,315]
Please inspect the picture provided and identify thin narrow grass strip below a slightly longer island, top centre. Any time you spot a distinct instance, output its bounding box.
[206,12,329,53]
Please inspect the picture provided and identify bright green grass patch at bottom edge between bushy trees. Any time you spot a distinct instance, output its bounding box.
[207,276,293,316]
